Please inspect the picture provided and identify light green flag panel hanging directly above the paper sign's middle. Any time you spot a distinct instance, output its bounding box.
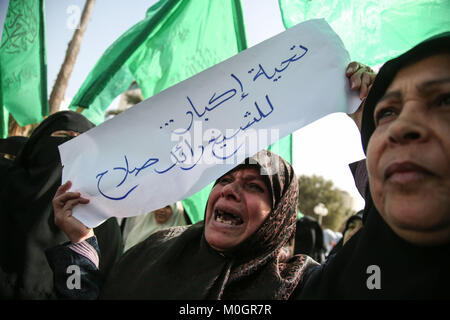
[127,0,246,98]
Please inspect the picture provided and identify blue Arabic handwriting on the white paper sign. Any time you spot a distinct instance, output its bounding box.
[96,41,308,200]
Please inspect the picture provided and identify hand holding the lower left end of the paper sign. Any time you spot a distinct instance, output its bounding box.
[52,181,94,243]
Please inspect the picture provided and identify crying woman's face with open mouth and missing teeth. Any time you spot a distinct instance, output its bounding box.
[205,168,272,251]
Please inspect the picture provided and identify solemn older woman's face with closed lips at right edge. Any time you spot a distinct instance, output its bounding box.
[367,54,450,245]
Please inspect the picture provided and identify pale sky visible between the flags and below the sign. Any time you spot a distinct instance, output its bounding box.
[0,0,364,210]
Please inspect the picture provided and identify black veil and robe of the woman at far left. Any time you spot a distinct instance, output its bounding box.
[0,111,122,299]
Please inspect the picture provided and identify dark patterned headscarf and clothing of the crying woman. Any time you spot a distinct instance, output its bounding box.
[103,150,315,299]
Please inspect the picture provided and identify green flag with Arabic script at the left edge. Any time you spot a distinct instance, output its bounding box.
[0,0,48,129]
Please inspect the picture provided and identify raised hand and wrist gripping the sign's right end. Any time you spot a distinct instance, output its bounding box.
[345,62,377,131]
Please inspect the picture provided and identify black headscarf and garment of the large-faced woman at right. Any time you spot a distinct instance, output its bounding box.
[295,32,450,299]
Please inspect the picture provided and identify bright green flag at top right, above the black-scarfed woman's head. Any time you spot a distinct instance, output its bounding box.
[279,0,450,66]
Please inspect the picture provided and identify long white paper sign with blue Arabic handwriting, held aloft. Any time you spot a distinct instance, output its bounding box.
[59,19,360,227]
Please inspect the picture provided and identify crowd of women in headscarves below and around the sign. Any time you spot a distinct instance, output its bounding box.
[0,33,450,300]
